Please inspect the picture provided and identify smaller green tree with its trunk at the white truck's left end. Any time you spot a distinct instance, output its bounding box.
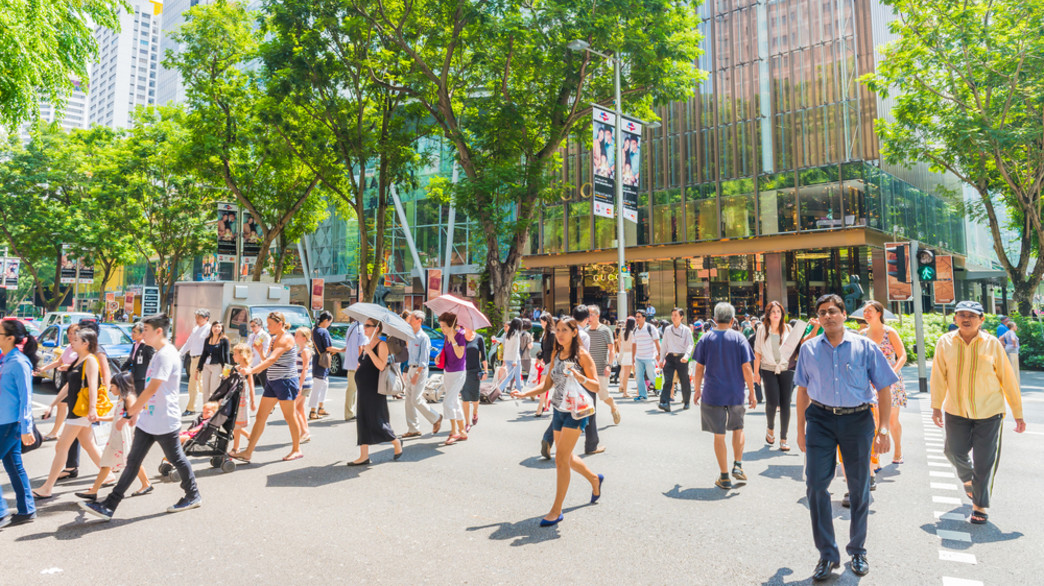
[122,107,222,310]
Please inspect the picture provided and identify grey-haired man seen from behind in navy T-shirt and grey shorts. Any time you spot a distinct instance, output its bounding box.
[692,303,758,490]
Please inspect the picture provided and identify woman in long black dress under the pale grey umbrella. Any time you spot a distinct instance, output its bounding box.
[348,320,402,466]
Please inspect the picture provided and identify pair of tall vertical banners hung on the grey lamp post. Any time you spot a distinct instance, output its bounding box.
[591,107,642,224]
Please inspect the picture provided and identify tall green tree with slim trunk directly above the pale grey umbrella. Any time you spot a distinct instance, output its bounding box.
[261,0,431,300]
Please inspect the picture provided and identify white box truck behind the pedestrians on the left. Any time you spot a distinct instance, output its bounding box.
[173,281,312,348]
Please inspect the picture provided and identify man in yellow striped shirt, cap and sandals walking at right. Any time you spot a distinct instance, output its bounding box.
[931,301,1026,524]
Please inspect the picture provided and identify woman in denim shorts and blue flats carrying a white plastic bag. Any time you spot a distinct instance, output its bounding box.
[512,318,604,526]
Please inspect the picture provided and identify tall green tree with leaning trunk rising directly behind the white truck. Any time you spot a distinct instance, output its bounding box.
[164,0,326,281]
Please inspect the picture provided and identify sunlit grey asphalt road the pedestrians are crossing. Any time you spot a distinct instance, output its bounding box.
[0,369,1044,585]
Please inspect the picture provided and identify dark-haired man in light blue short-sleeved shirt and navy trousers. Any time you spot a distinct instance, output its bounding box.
[793,295,899,582]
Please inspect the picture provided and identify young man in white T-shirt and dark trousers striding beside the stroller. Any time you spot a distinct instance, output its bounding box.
[79,313,203,521]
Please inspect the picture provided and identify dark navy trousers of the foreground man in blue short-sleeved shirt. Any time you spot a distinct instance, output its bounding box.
[805,405,874,563]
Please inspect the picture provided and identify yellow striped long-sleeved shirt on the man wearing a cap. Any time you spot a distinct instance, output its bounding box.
[931,331,1022,419]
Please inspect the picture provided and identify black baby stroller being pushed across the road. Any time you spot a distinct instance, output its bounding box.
[160,371,243,483]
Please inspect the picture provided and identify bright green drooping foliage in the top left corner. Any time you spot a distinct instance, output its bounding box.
[0,0,126,127]
